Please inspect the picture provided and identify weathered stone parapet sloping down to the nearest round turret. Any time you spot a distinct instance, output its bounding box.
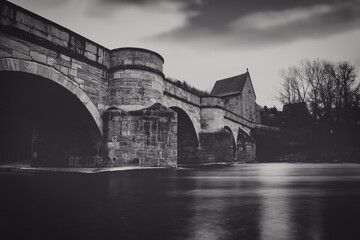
[0,2,110,67]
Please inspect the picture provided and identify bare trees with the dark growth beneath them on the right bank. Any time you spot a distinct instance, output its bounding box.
[275,59,360,159]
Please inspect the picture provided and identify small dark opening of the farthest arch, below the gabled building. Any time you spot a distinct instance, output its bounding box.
[237,127,256,162]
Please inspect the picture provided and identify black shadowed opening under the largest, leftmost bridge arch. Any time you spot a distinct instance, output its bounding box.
[0,72,102,166]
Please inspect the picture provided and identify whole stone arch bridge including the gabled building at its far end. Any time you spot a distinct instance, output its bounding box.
[0,2,276,167]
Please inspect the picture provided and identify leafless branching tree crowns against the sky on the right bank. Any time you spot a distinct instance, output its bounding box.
[275,59,360,124]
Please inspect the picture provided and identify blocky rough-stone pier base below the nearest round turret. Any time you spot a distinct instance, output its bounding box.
[104,103,177,167]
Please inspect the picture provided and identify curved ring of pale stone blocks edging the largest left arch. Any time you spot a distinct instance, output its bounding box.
[0,58,103,134]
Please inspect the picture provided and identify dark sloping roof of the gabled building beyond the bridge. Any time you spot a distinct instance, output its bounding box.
[210,72,249,97]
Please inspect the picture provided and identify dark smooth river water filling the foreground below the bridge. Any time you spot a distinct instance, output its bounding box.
[0,163,360,240]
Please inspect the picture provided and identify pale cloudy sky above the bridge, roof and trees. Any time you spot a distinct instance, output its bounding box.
[10,0,360,110]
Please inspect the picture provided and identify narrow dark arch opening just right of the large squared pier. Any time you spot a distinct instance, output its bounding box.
[170,107,199,164]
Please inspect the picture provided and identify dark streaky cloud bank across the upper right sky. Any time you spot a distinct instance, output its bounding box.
[97,0,360,45]
